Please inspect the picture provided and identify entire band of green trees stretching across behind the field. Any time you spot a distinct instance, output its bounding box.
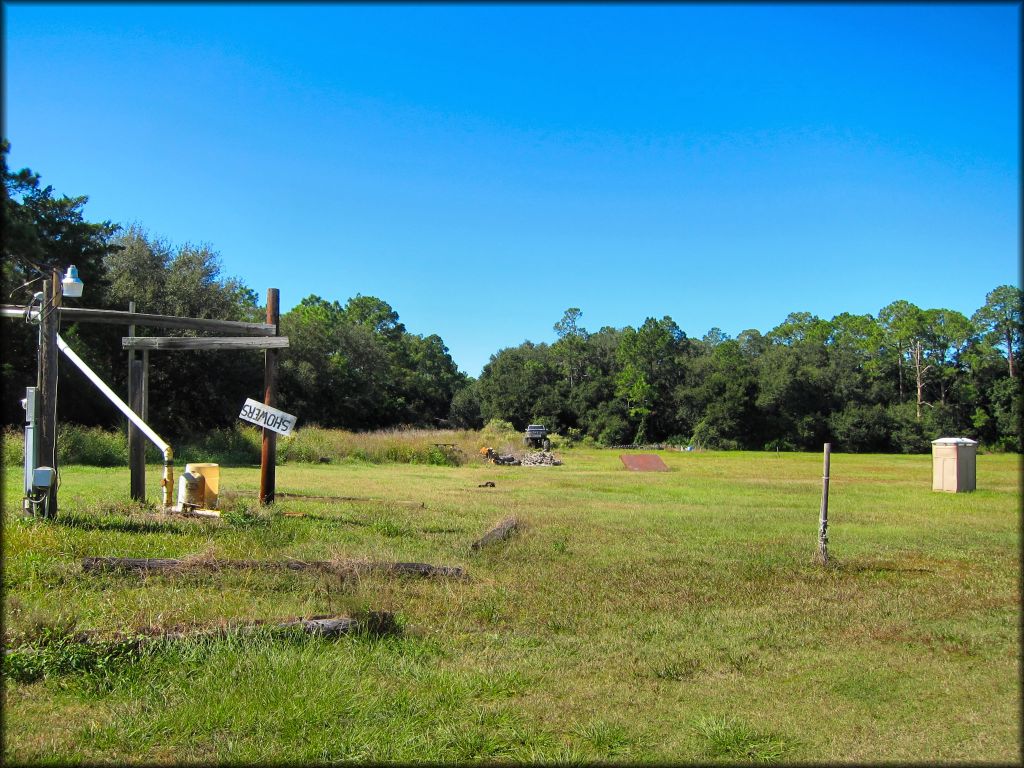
[0,141,1022,452]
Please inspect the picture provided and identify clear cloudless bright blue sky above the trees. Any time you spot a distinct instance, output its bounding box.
[3,3,1021,376]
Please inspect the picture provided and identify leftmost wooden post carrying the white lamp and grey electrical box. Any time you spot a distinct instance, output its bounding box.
[38,269,61,517]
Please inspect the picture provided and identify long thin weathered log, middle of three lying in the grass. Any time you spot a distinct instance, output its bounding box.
[82,557,468,579]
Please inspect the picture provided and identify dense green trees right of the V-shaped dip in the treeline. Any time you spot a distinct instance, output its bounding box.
[466,301,1022,453]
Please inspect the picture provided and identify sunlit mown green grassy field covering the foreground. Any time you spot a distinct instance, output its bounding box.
[3,449,1021,764]
